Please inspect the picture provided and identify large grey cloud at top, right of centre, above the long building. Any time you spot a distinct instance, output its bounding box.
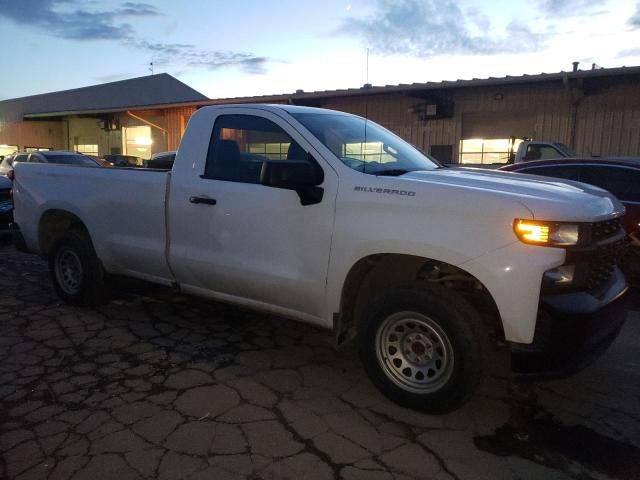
[339,0,543,57]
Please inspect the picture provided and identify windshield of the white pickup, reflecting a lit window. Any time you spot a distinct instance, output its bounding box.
[292,113,440,176]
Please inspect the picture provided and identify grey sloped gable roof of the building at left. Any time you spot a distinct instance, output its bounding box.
[0,73,207,118]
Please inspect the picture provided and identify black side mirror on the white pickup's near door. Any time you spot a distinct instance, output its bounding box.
[260,159,324,205]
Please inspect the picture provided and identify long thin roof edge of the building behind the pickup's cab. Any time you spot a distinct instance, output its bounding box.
[199,66,640,105]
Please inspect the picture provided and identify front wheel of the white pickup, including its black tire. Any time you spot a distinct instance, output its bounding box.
[358,283,487,413]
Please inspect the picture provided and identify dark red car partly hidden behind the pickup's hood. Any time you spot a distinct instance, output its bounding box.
[499,158,640,238]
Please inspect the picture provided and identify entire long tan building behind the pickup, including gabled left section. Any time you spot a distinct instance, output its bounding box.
[0,67,640,164]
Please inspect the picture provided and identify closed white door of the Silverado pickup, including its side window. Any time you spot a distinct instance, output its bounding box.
[170,108,338,321]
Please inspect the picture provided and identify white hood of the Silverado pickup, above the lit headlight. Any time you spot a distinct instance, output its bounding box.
[398,168,624,222]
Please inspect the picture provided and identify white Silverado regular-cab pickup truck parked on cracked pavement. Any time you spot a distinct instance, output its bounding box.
[13,105,627,412]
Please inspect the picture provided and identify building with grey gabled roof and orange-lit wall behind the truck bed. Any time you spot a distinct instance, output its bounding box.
[0,74,207,159]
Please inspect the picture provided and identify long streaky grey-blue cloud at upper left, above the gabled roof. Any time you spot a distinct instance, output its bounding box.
[0,0,270,74]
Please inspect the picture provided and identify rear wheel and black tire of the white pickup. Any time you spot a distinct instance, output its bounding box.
[49,230,108,307]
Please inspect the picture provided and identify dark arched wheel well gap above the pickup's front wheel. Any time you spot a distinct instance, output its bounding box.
[334,253,505,344]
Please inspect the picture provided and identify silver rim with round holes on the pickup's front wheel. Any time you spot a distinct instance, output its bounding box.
[376,312,454,394]
